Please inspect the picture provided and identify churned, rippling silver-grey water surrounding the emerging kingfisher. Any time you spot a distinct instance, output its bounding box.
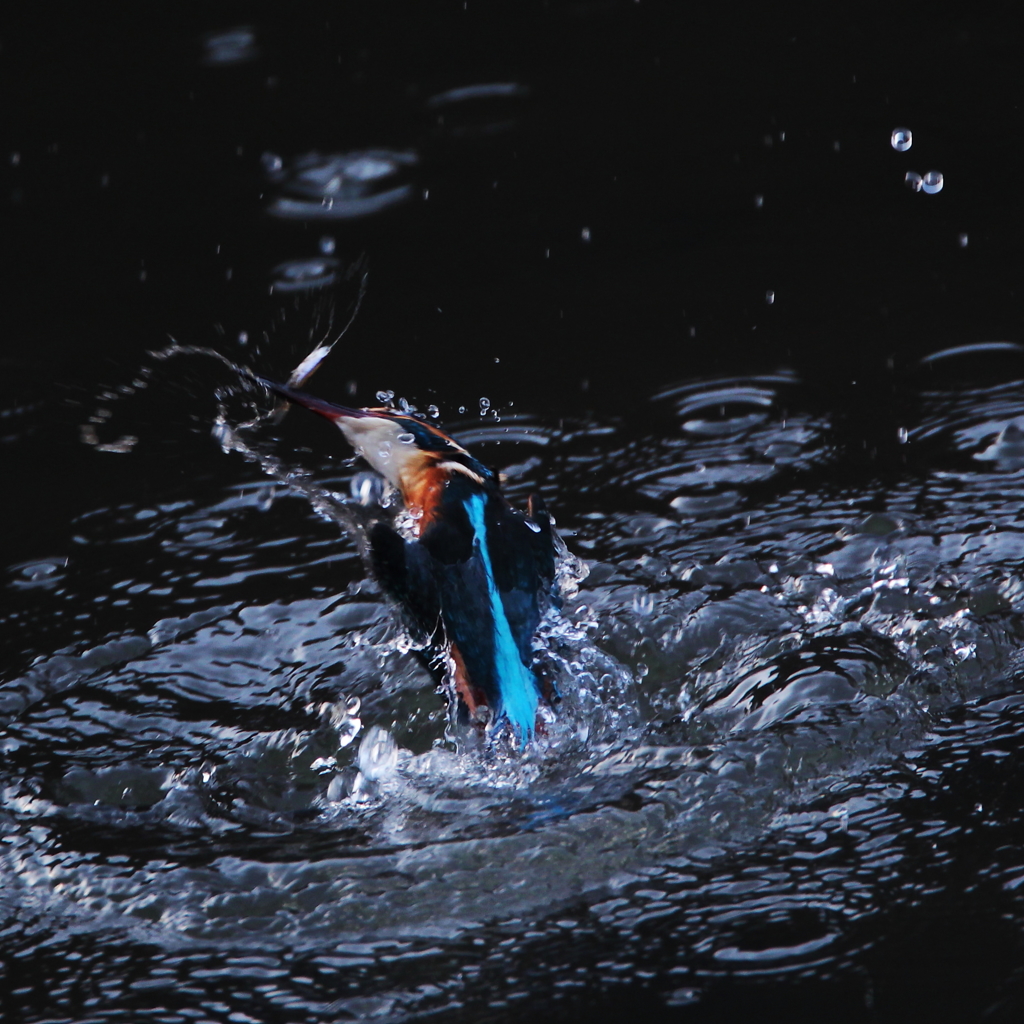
[0,350,1024,1021]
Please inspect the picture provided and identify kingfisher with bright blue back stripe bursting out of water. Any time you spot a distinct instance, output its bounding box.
[256,377,555,748]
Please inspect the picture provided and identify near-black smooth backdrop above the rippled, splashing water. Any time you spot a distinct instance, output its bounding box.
[0,0,1024,1019]
